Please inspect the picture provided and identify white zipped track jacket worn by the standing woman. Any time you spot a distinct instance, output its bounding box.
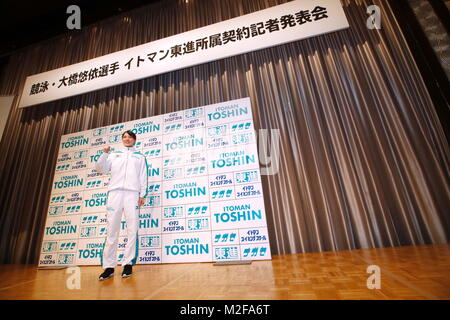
[95,147,147,198]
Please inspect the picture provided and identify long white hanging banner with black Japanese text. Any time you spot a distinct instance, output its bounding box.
[19,0,349,107]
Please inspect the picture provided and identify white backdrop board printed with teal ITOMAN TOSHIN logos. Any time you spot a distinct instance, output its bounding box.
[39,98,271,266]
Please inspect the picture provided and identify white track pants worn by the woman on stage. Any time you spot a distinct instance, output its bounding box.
[101,190,139,269]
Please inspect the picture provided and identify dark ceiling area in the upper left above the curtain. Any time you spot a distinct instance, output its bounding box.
[0,0,162,60]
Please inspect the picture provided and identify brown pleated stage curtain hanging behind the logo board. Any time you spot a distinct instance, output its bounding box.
[0,0,450,263]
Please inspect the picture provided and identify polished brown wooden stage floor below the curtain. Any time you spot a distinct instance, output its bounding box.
[0,244,450,300]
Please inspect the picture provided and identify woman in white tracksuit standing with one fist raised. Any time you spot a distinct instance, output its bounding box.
[95,131,147,280]
